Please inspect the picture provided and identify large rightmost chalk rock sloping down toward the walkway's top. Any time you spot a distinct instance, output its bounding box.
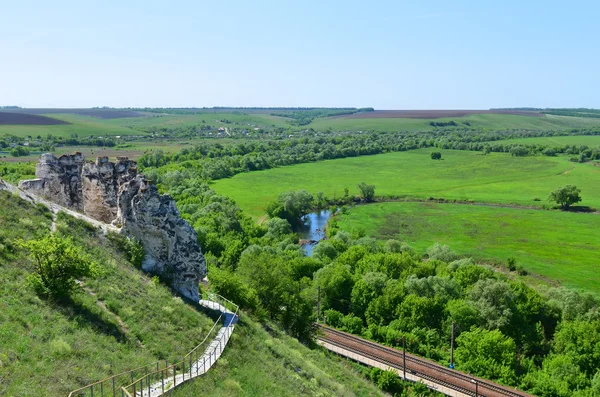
[117,175,206,301]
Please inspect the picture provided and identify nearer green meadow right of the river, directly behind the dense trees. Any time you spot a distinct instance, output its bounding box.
[337,203,600,294]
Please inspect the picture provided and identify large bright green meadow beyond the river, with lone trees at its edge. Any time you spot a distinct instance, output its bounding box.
[213,149,600,217]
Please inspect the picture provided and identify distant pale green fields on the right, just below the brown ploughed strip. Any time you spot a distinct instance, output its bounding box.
[306,113,600,132]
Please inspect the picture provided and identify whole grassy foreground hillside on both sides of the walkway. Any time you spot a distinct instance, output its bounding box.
[0,191,394,397]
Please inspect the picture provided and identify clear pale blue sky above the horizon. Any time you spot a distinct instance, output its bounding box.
[0,0,600,109]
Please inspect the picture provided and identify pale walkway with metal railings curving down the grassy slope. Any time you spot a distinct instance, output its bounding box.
[121,294,239,397]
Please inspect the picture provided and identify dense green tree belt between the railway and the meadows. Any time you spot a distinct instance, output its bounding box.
[146,156,600,396]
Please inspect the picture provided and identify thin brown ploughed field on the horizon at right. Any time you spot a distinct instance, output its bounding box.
[334,110,544,119]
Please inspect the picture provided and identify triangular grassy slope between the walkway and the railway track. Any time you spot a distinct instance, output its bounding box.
[172,316,383,397]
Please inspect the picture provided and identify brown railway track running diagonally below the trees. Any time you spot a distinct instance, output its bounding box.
[317,325,534,397]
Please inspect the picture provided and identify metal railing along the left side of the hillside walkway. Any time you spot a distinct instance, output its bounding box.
[68,293,239,397]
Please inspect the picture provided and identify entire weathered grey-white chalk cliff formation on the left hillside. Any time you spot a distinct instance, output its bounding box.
[19,153,206,300]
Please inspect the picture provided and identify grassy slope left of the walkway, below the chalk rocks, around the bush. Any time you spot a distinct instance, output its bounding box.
[0,191,213,397]
